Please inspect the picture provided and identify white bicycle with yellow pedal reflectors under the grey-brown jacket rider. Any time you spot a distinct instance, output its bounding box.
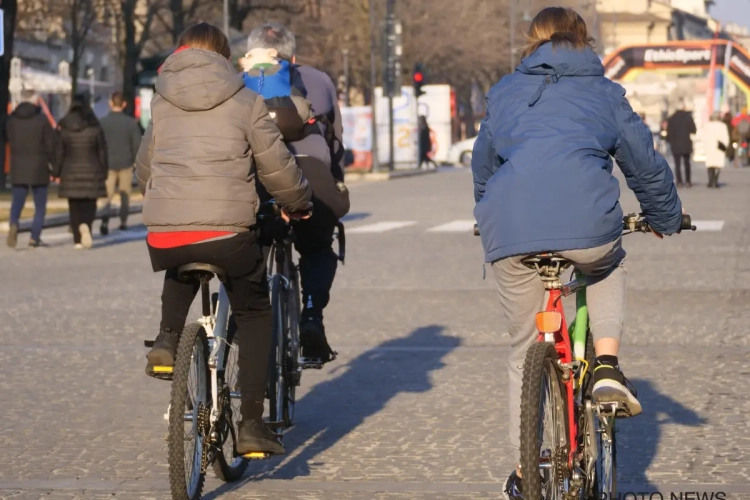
[144,263,278,500]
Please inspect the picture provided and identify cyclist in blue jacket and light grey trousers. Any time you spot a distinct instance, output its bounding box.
[472,7,682,500]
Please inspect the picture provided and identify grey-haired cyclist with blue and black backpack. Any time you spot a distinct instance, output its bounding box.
[247,24,349,362]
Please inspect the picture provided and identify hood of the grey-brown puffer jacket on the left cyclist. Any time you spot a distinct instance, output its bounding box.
[156,48,245,111]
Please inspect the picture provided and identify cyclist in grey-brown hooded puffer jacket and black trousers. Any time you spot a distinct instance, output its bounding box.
[136,23,311,454]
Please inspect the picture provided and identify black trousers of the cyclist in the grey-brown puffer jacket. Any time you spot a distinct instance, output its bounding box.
[148,230,273,420]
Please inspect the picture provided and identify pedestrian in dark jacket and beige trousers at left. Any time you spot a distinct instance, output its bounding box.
[99,92,142,236]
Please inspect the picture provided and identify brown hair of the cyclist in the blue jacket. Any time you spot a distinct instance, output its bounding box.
[522,7,594,57]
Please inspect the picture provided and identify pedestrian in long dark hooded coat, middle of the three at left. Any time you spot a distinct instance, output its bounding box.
[55,95,109,249]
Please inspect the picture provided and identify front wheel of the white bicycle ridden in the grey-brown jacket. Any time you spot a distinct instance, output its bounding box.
[213,315,248,482]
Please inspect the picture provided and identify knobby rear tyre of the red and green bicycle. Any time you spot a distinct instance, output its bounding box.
[520,342,570,500]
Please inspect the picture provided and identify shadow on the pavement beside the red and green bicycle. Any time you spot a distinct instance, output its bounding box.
[617,379,708,491]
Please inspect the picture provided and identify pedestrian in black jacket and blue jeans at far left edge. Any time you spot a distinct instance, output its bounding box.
[3,90,55,248]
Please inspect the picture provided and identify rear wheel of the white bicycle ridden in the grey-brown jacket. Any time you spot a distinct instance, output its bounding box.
[167,323,211,500]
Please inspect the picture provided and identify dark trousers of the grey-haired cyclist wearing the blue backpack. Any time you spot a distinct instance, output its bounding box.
[293,206,338,320]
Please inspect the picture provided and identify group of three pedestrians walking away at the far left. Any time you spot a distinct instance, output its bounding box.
[2,90,142,249]
